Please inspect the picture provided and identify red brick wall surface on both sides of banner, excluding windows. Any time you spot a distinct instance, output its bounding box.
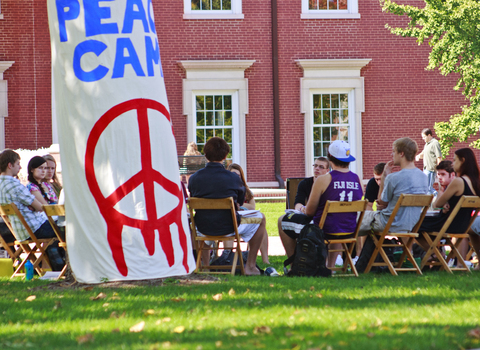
[0,0,478,181]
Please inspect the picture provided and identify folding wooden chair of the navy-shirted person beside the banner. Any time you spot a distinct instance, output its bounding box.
[188,197,245,275]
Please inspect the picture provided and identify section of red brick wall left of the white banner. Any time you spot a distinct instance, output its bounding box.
[0,0,52,149]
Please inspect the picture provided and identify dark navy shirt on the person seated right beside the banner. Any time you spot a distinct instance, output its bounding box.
[188,162,245,236]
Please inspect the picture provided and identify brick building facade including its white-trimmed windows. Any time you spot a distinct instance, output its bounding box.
[0,0,472,185]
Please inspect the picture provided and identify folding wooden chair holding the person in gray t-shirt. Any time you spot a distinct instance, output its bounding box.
[365,194,433,276]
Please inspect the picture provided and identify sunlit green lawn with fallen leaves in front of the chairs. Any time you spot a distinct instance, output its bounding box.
[0,257,480,350]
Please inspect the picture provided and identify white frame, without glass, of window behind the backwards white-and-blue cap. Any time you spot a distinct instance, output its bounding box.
[296,59,371,179]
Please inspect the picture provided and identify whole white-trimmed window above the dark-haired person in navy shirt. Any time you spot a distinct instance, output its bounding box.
[179,60,255,171]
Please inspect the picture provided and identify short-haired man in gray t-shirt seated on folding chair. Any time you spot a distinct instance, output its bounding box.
[359,137,428,236]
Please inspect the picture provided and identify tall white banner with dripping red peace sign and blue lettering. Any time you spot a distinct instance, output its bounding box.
[48,0,195,283]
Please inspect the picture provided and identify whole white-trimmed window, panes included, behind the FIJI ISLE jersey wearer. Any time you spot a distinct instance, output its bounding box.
[296,59,371,178]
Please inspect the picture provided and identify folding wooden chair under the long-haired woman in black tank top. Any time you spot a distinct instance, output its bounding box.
[421,196,480,273]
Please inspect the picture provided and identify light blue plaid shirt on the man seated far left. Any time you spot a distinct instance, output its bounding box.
[0,175,47,241]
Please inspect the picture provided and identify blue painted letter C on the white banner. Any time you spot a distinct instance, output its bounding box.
[73,40,108,82]
